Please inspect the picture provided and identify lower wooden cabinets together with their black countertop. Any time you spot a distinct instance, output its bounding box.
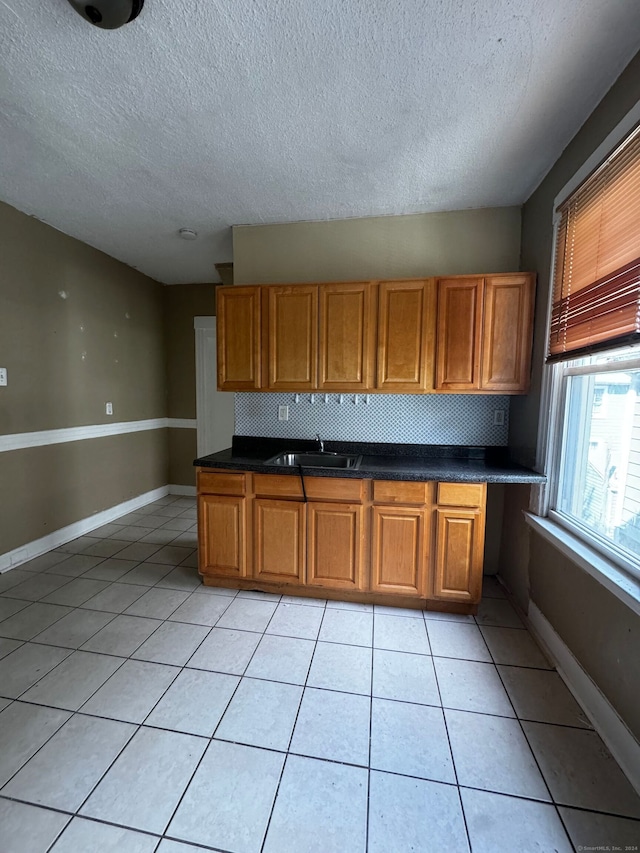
[194,436,545,613]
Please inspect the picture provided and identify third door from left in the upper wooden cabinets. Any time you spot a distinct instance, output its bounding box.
[318,282,377,391]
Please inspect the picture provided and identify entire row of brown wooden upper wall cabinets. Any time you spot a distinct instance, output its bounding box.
[218,273,535,394]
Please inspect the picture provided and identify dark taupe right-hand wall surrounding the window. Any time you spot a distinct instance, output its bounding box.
[500,54,640,737]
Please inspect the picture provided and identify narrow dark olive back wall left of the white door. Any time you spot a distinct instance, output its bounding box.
[163,284,216,486]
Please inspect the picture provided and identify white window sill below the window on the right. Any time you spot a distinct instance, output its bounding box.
[524,512,640,616]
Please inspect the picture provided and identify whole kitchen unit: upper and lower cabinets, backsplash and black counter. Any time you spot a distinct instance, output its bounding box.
[196,273,543,613]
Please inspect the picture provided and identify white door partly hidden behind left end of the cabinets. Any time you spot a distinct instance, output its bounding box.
[193,317,235,456]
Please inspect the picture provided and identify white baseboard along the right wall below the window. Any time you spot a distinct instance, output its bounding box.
[528,601,640,794]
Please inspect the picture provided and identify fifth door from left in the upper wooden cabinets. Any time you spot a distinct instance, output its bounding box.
[436,278,483,392]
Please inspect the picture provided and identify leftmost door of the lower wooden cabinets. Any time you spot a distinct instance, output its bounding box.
[198,495,246,578]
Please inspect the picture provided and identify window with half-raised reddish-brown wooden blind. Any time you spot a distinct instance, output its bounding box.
[547,111,640,578]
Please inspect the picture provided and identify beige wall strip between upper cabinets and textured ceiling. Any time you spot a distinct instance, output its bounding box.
[233,207,520,284]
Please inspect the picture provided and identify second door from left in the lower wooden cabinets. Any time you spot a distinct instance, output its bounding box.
[253,499,306,584]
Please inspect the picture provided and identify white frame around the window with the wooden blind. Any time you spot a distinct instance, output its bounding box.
[530,95,640,581]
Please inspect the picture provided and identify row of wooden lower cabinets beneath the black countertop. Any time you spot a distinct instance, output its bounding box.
[198,470,486,613]
